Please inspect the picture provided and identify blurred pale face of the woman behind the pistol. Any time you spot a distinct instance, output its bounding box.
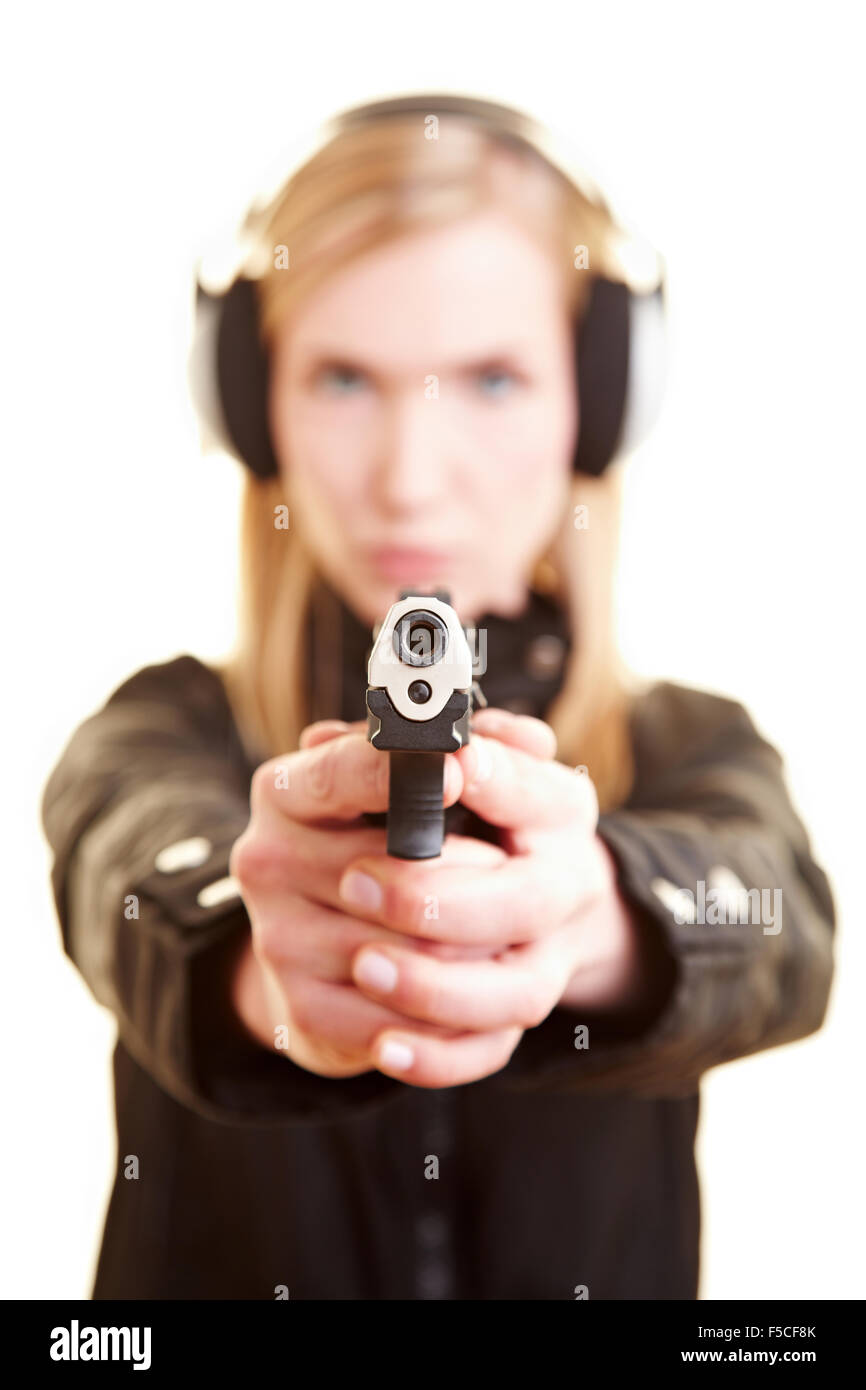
[270,210,577,624]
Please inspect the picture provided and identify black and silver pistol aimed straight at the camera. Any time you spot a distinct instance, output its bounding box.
[367,589,485,859]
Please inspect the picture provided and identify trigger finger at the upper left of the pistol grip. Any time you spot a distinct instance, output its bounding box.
[250,731,463,823]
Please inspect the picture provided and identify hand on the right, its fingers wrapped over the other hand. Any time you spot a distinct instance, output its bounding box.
[339,710,656,1084]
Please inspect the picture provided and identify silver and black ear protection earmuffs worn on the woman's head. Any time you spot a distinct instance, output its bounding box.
[189,93,664,478]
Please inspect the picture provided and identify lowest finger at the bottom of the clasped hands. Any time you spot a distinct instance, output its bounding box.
[371,1029,523,1088]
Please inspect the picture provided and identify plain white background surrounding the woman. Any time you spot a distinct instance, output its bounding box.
[0,0,866,1298]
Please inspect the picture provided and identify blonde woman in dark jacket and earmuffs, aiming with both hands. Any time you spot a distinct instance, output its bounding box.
[43,96,834,1300]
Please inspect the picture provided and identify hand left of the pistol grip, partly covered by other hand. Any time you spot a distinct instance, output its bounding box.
[229,720,522,1086]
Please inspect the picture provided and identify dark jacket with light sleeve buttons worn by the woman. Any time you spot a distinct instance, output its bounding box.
[42,581,835,1300]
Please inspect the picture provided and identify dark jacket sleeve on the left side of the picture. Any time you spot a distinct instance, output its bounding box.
[42,656,400,1125]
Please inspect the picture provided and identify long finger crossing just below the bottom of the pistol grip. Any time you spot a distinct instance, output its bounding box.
[339,830,607,948]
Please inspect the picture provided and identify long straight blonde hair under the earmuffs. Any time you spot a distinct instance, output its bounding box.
[221,115,647,810]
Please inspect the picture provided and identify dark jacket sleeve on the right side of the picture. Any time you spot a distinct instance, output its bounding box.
[500,682,835,1097]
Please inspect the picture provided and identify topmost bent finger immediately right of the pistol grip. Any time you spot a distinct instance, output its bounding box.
[455,735,598,830]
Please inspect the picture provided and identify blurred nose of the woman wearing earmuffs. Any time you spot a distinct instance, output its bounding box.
[375,385,446,512]
